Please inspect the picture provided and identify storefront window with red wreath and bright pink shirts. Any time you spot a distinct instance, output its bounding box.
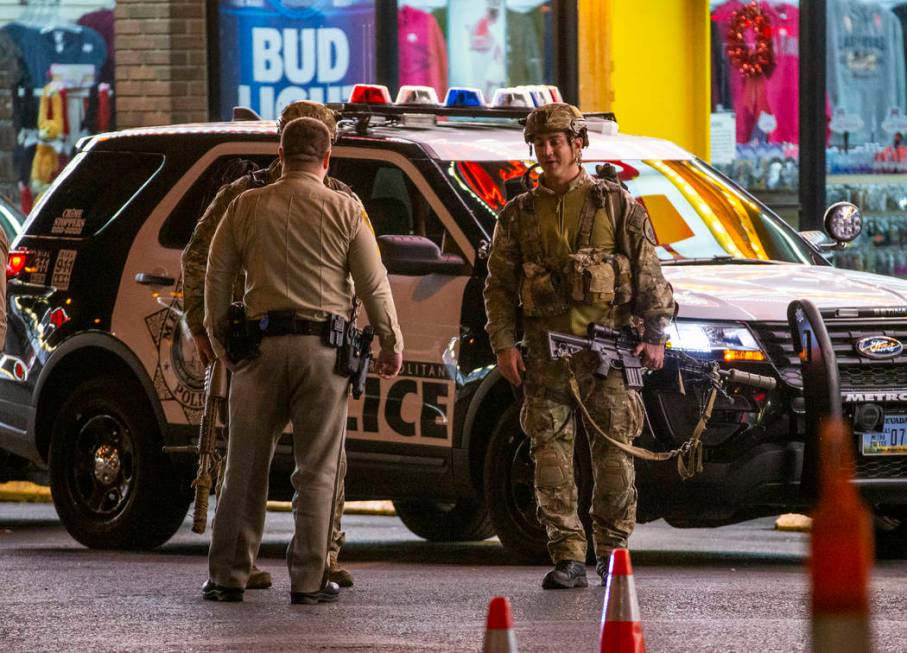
[711,0,800,218]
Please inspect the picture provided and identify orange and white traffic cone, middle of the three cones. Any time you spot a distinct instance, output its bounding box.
[599,549,646,653]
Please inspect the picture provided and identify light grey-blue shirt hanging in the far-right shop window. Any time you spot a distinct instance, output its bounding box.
[827,0,907,144]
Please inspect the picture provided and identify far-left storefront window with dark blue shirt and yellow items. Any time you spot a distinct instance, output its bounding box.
[0,0,114,213]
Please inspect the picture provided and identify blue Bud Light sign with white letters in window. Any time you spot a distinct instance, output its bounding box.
[219,0,375,120]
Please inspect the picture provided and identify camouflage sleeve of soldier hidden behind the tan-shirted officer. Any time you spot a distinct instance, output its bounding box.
[180,177,250,335]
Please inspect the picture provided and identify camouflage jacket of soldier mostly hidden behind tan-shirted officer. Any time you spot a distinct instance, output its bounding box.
[181,160,359,335]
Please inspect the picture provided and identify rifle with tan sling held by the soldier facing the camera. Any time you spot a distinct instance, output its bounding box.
[548,324,776,480]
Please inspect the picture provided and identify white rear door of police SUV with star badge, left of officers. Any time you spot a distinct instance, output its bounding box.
[112,142,277,426]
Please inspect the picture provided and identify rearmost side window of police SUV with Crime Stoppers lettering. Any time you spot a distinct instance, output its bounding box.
[28,151,164,238]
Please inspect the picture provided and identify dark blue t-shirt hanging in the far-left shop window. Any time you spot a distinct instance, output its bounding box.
[0,23,107,88]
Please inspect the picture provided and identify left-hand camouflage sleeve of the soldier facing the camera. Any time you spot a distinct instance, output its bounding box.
[485,201,523,353]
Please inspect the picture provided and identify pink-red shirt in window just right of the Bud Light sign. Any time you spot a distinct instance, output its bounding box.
[397,5,447,98]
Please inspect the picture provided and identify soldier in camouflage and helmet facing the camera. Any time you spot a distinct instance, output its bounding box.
[485,104,674,589]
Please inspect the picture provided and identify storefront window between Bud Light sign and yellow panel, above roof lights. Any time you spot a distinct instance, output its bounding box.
[398,0,554,100]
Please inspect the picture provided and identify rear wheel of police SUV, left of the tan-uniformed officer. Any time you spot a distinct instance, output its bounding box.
[49,377,191,549]
